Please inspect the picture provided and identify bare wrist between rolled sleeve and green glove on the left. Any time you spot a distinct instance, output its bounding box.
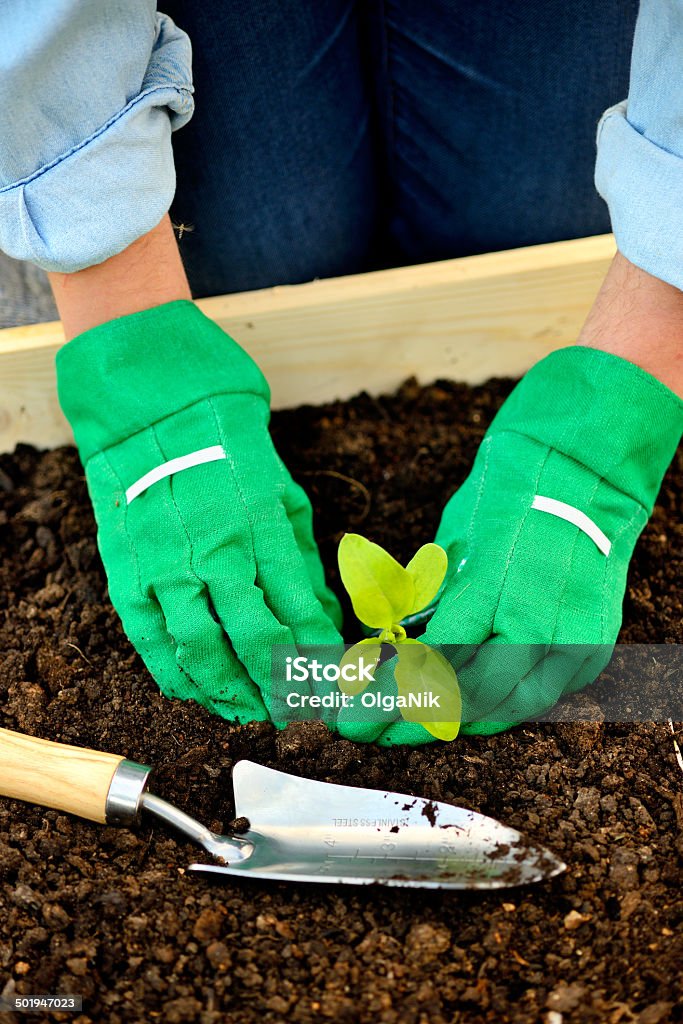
[48,215,191,341]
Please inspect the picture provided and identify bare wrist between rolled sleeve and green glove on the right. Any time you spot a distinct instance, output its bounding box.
[579,253,683,397]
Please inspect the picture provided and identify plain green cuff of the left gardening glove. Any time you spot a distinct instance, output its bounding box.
[56,300,270,464]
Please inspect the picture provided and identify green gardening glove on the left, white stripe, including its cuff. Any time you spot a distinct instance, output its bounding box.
[57,301,341,722]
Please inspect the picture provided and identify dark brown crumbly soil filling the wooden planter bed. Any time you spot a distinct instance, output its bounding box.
[0,382,683,1024]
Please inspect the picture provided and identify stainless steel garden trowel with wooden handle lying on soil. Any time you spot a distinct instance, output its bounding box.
[0,729,566,889]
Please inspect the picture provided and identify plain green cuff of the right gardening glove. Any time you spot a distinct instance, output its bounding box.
[488,345,683,512]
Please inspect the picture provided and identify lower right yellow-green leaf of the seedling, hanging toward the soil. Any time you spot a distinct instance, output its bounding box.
[394,639,462,740]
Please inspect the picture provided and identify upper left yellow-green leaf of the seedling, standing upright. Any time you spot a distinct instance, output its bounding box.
[338,534,415,630]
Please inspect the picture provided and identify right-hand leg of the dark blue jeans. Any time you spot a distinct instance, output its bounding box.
[368,0,643,262]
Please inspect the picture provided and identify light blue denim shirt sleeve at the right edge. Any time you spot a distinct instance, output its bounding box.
[595,0,683,288]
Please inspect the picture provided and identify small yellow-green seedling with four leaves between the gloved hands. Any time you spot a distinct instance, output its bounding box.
[339,534,461,739]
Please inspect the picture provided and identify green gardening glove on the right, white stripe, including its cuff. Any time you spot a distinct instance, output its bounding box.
[344,346,683,744]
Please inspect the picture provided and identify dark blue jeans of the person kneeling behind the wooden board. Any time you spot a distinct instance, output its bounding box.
[163,0,638,296]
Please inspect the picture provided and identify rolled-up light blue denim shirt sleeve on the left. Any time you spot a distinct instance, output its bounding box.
[0,0,194,272]
